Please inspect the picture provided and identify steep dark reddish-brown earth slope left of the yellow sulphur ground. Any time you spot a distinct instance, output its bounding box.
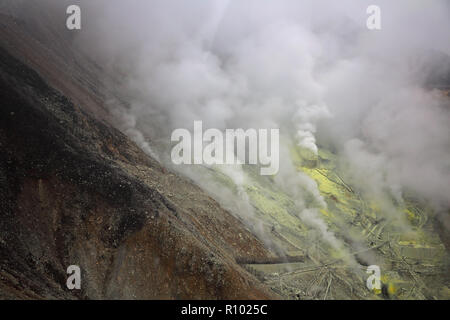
[0,6,277,299]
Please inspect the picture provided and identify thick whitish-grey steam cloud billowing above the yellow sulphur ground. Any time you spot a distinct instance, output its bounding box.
[45,0,450,243]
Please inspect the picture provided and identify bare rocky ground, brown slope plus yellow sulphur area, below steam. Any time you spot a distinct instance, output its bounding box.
[0,0,450,299]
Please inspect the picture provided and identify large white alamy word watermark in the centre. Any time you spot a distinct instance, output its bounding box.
[171,121,280,175]
